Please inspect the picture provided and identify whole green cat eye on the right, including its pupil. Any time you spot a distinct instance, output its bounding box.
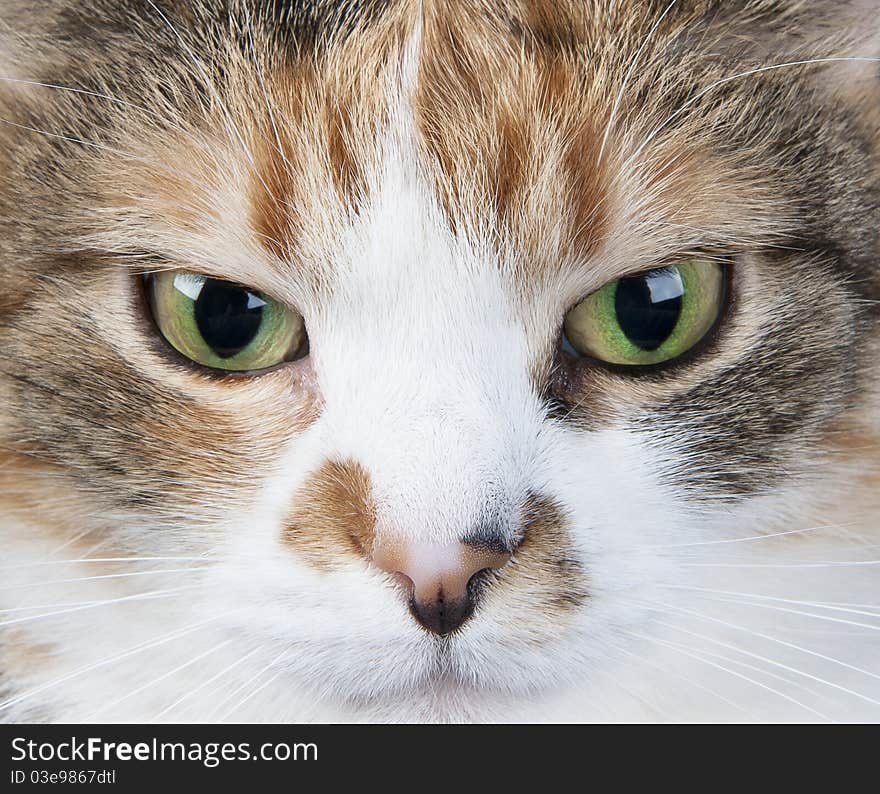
[564,259,725,366]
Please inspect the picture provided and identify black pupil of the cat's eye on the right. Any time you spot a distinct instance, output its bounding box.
[614,267,684,351]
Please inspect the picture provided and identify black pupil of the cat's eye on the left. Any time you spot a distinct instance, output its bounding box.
[194,278,265,358]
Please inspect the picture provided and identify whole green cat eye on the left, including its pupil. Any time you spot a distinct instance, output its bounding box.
[147,271,309,372]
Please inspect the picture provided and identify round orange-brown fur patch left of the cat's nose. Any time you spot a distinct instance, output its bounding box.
[281,461,376,571]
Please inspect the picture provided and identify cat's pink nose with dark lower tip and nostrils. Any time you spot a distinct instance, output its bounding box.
[373,541,510,636]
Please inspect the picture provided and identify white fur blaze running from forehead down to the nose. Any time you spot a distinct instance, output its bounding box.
[310,35,541,542]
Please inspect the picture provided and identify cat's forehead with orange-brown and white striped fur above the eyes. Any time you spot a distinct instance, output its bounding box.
[103,4,796,306]
